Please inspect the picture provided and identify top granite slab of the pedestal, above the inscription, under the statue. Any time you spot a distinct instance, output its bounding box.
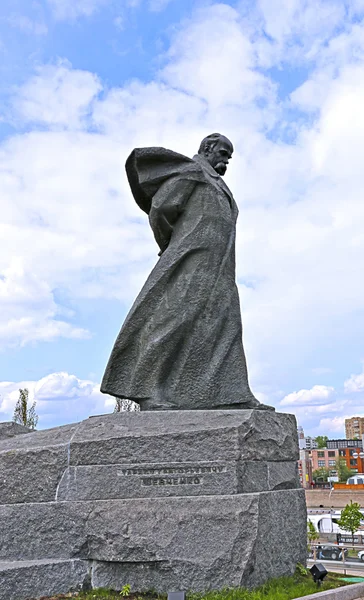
[70,410,298,466]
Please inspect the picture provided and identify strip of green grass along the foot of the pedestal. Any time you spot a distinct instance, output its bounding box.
[42,573,356,600]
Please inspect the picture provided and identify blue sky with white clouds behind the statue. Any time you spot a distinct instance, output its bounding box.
[0,0,364,437]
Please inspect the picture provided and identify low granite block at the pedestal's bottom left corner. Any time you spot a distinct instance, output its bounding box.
[0,560,90,600]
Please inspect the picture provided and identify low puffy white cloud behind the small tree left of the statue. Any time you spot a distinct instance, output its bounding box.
[0,372,115,429]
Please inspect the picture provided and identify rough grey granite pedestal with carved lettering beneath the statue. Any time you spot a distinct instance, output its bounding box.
[0,410,306,600]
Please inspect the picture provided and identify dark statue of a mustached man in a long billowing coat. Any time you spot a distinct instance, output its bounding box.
[101,133,270,410]
